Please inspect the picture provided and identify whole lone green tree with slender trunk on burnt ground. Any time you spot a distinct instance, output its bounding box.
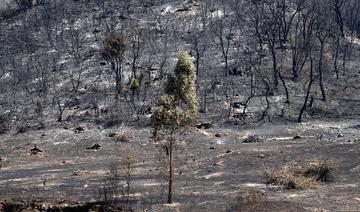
[152,50,198,204]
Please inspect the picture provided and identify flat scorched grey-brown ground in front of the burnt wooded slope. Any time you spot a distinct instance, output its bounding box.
[0,120,360,211]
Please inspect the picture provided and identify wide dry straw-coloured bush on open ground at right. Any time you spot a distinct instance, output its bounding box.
[265,160,331,189]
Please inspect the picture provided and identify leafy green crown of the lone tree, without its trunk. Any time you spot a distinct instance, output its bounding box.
[152,50,198,129]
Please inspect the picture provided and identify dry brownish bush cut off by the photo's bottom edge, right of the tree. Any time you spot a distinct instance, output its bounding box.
[227,189,268,212]
